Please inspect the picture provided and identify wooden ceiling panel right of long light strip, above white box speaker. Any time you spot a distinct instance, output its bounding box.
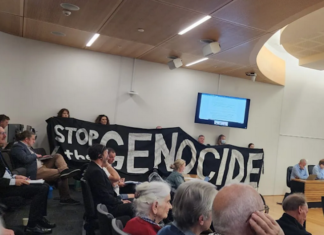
[162,19,264,55]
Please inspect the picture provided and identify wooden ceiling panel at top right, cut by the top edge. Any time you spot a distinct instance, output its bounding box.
[212,0,323,31]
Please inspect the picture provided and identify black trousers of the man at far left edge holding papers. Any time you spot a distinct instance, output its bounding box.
[0,184,49,227]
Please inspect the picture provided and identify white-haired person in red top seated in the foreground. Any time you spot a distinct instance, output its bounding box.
[124,182,172,235]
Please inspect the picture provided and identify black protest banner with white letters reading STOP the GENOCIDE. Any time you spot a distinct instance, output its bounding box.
[47,118,264,188]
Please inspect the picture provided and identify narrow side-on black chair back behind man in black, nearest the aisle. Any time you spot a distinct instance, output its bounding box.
[81,178,98,235]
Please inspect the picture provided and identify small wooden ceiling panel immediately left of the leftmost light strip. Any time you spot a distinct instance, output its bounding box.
[24,19,93,48]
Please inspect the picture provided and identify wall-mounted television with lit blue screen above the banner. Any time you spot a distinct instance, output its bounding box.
[195,93,250,129]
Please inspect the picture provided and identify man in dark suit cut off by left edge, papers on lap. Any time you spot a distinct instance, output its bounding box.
[0,127,55,234]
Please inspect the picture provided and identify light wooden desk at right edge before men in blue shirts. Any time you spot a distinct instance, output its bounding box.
[293,179,324,203]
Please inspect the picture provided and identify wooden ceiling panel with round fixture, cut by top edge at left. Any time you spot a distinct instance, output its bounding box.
[25,0,122,32]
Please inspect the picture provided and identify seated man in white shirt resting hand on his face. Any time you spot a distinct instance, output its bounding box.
[103,148,134,199]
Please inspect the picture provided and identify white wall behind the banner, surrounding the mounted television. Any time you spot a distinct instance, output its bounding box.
[0,33,284,195]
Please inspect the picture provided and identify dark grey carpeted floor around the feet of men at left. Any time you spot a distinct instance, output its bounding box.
[4,188,84,235]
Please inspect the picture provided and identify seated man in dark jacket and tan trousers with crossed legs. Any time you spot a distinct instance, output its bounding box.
[10,131,80,205]
